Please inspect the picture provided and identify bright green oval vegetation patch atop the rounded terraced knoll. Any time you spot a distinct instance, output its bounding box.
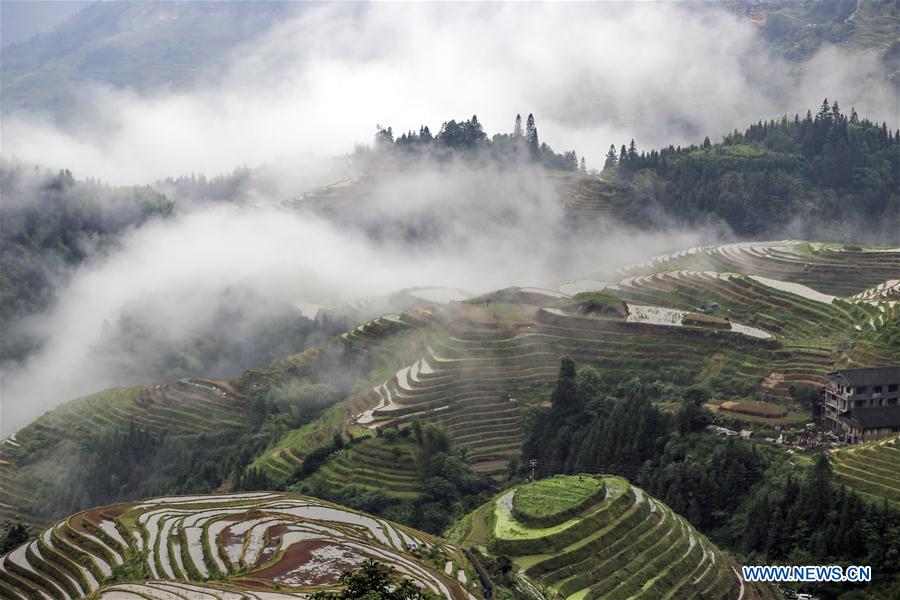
[512,475,605,528]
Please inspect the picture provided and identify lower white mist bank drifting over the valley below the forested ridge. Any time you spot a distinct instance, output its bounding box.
[2,157,715,434]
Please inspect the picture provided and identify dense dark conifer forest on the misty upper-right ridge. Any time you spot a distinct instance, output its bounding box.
[603,100,900,243]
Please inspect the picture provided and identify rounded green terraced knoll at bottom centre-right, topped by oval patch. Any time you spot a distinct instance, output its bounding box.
[446,475,766,600]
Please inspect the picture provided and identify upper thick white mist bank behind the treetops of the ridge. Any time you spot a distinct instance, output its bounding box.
[2,2,898,184]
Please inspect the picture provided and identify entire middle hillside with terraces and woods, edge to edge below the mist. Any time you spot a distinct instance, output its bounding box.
[0,241,900,525]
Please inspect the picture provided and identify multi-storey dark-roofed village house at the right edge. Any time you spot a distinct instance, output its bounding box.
[822,365,900,444]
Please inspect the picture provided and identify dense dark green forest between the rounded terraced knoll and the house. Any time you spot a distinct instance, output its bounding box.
[523,358,900,598]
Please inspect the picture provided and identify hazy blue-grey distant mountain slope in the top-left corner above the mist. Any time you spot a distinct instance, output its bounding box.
[0,2,296,119]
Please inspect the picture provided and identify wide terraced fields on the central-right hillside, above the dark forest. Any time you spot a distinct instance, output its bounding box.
[332,242,900,473]
